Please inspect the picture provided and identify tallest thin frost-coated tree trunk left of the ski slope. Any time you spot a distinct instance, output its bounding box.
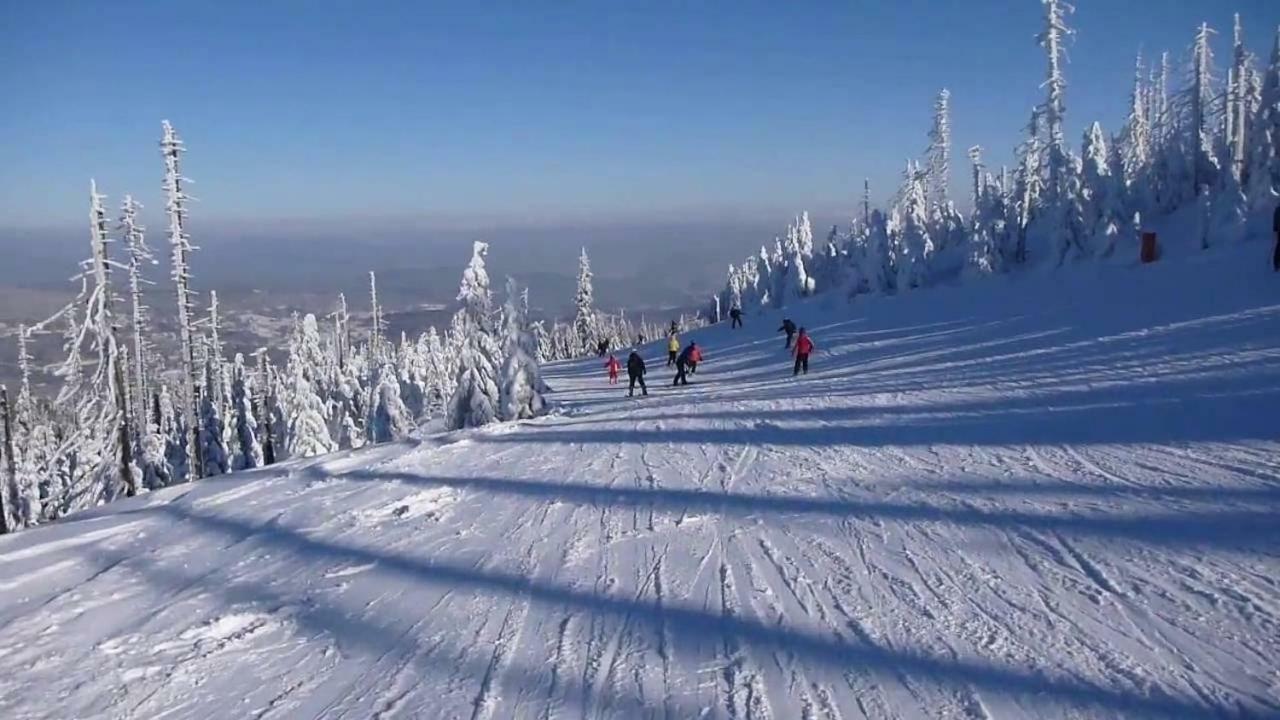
[160,120,204,479]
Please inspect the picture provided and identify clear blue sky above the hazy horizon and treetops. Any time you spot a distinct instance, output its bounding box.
[0,0,1280,227]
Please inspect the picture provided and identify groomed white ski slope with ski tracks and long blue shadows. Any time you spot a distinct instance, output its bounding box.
[0,243,1280,719]
